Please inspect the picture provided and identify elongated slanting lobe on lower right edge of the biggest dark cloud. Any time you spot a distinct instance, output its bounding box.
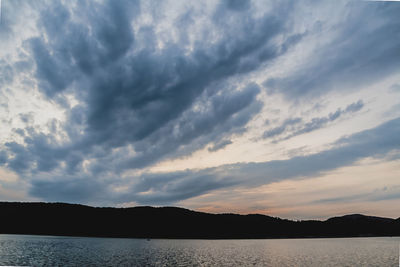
[111,84,261,171]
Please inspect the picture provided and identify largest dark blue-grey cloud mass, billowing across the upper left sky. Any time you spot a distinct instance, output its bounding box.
[0,1,299,177]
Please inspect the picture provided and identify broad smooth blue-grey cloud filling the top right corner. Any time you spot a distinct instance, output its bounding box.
[264,1,400,99]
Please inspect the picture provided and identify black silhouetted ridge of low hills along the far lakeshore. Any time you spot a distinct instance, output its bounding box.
[0,202,400,239]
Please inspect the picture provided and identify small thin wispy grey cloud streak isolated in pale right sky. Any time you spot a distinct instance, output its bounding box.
[263,100,364,142]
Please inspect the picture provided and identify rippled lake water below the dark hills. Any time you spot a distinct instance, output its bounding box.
[0,235,400,266]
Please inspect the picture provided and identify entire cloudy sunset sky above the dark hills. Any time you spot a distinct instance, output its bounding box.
[0,0,400,219]
